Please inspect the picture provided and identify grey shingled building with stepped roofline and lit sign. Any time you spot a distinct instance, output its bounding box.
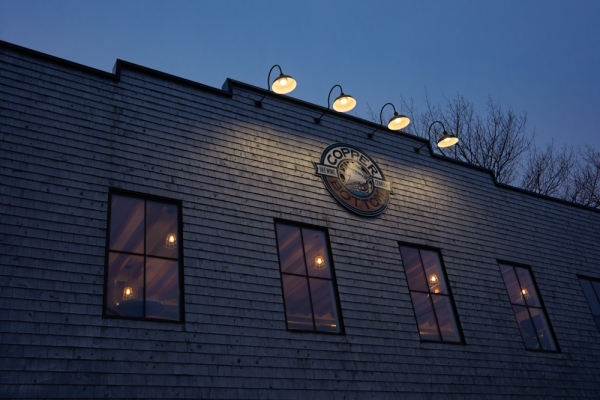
[0,42,600,399]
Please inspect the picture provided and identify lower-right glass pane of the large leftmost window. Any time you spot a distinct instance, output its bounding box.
[146,257,179,320]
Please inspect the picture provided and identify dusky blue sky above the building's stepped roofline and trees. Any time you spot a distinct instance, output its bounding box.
[0,0,600,150]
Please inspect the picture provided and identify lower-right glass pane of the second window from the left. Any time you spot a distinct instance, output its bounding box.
[309,278,340,332]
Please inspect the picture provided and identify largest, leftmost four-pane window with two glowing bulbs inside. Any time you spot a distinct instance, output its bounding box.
[104,193,183,321]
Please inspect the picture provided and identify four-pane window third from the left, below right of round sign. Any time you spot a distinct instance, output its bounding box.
[400,245,463,343]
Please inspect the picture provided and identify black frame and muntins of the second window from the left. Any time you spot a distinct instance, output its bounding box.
[273,218,346,336]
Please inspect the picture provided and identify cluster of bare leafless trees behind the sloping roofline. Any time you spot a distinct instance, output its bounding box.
[367,91,600,208]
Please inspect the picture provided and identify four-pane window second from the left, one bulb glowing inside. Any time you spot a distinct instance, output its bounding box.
[275,222,342,333]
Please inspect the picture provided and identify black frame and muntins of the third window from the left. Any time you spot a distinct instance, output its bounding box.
[398,241,467,346]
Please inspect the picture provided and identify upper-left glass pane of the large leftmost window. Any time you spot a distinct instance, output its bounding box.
[109,195,144,254]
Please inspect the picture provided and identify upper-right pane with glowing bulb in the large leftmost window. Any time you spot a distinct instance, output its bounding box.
[146,201,180,258]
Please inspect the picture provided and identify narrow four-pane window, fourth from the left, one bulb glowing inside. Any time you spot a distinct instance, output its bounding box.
[500,263,558,351]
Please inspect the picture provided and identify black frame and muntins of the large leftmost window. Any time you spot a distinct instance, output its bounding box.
[102,188,185,324]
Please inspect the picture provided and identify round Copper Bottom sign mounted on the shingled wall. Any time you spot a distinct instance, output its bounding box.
[314,143,392,217]
